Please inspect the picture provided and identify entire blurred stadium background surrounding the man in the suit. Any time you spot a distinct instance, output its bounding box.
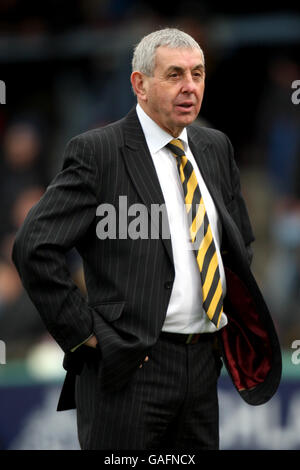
[0,0,300,449]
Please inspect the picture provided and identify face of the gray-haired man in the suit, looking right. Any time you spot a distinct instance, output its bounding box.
[139,46,205,137]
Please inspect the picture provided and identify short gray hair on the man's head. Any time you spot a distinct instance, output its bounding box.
[132,28,204,77]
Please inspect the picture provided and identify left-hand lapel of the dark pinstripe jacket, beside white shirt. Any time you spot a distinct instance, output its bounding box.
[122,109,173,263]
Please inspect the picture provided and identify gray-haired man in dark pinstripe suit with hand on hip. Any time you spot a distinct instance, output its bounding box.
[13,29,281,449]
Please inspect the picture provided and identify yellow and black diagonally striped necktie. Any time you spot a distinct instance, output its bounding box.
[167,139,223,327]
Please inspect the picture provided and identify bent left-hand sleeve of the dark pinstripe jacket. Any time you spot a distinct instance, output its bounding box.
[12,136,98,352]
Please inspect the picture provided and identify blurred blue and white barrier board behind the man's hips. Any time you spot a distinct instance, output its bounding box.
[0,351,300,450]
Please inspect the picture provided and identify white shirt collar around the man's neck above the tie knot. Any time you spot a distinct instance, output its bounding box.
[136,104,188,154]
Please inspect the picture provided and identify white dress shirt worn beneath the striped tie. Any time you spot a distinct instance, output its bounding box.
[136,104,227,334]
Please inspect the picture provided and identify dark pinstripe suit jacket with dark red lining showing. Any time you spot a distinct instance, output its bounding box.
[13,110,281,409]
